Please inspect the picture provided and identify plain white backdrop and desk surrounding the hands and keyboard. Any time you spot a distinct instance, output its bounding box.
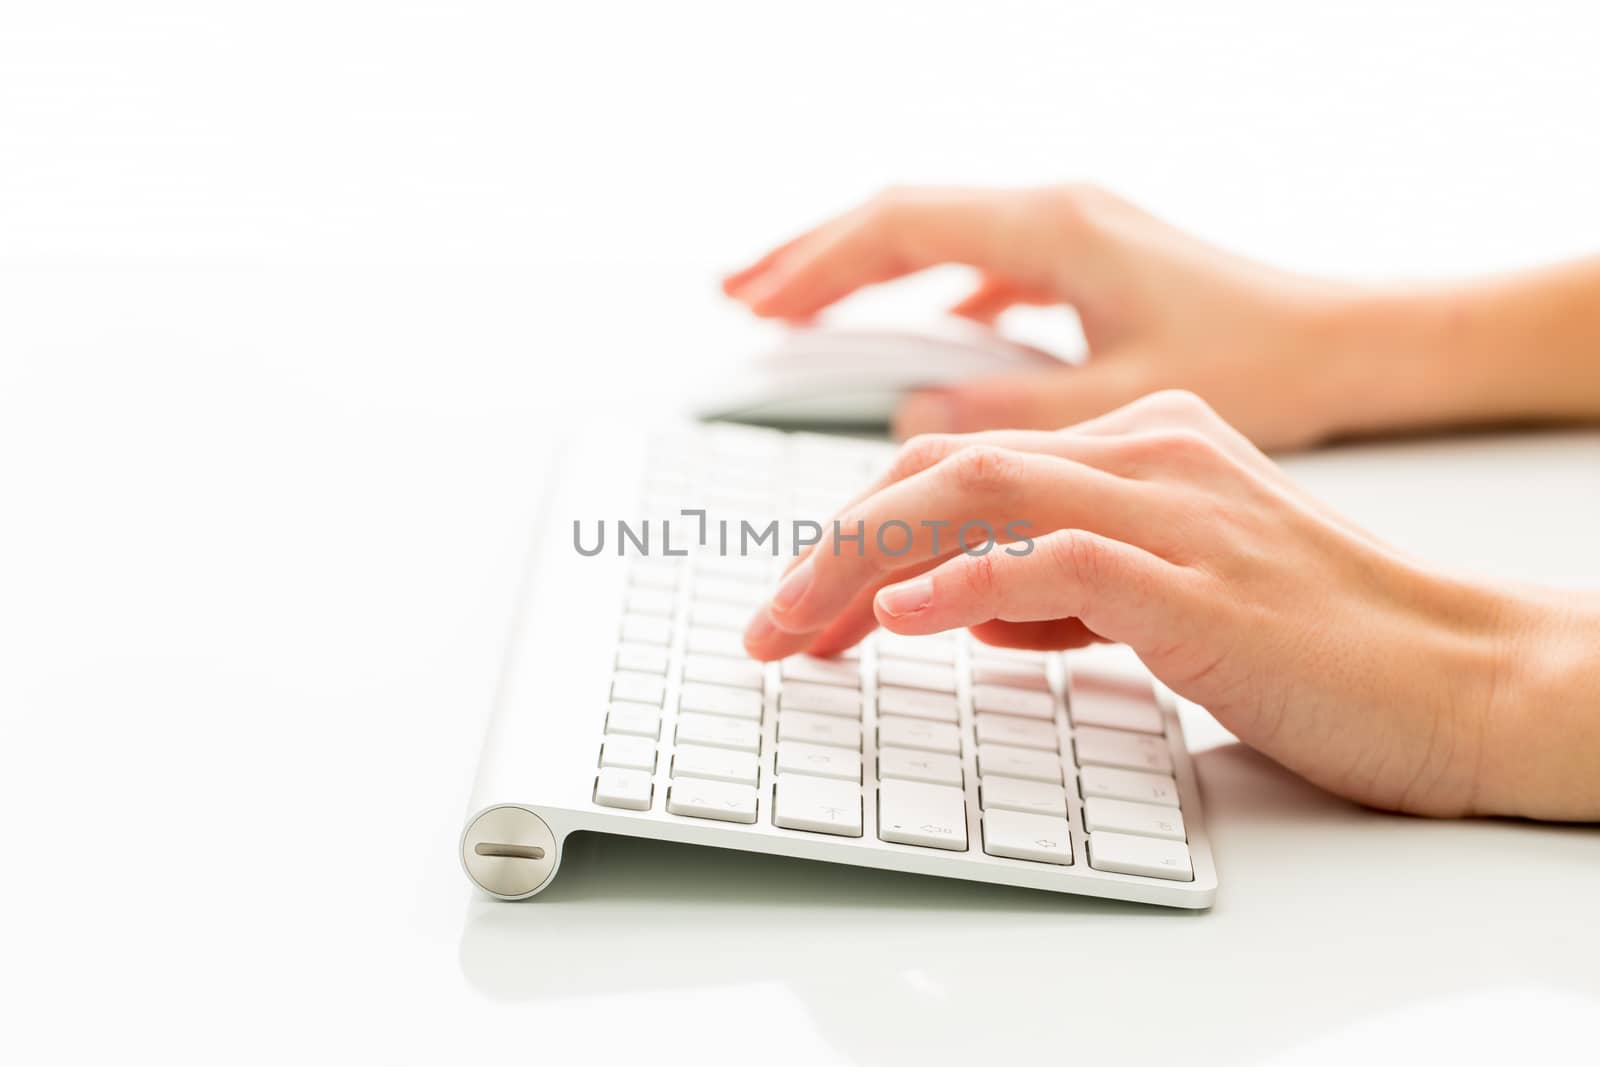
[0,0,1600,1062]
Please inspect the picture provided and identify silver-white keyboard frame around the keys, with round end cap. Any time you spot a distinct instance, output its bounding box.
[461,432,1218,909]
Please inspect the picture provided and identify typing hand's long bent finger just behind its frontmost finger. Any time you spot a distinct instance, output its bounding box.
[766,446,1178,633]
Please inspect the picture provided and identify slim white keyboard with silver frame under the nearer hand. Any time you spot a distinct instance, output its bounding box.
[462,427,1216,907]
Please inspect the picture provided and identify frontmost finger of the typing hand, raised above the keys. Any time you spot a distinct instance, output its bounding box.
[875,530,1198,651]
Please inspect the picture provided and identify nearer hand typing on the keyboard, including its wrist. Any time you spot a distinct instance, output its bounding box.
[746,392,1600,819]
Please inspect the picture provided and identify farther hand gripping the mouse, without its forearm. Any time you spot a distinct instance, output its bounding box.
[723,186,1354,448]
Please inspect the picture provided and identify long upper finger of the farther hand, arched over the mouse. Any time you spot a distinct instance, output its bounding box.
[741,189,1069,318]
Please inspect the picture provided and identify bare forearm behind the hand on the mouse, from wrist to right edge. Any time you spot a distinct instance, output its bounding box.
[1325,259,1600,435]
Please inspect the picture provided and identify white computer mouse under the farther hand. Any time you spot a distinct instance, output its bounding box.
[696,317,1062,432]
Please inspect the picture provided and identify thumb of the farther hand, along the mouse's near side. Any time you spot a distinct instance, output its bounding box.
[894,357,1150,438]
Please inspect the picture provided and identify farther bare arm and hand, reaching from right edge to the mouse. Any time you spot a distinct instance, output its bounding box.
[725,186,1600,448]
